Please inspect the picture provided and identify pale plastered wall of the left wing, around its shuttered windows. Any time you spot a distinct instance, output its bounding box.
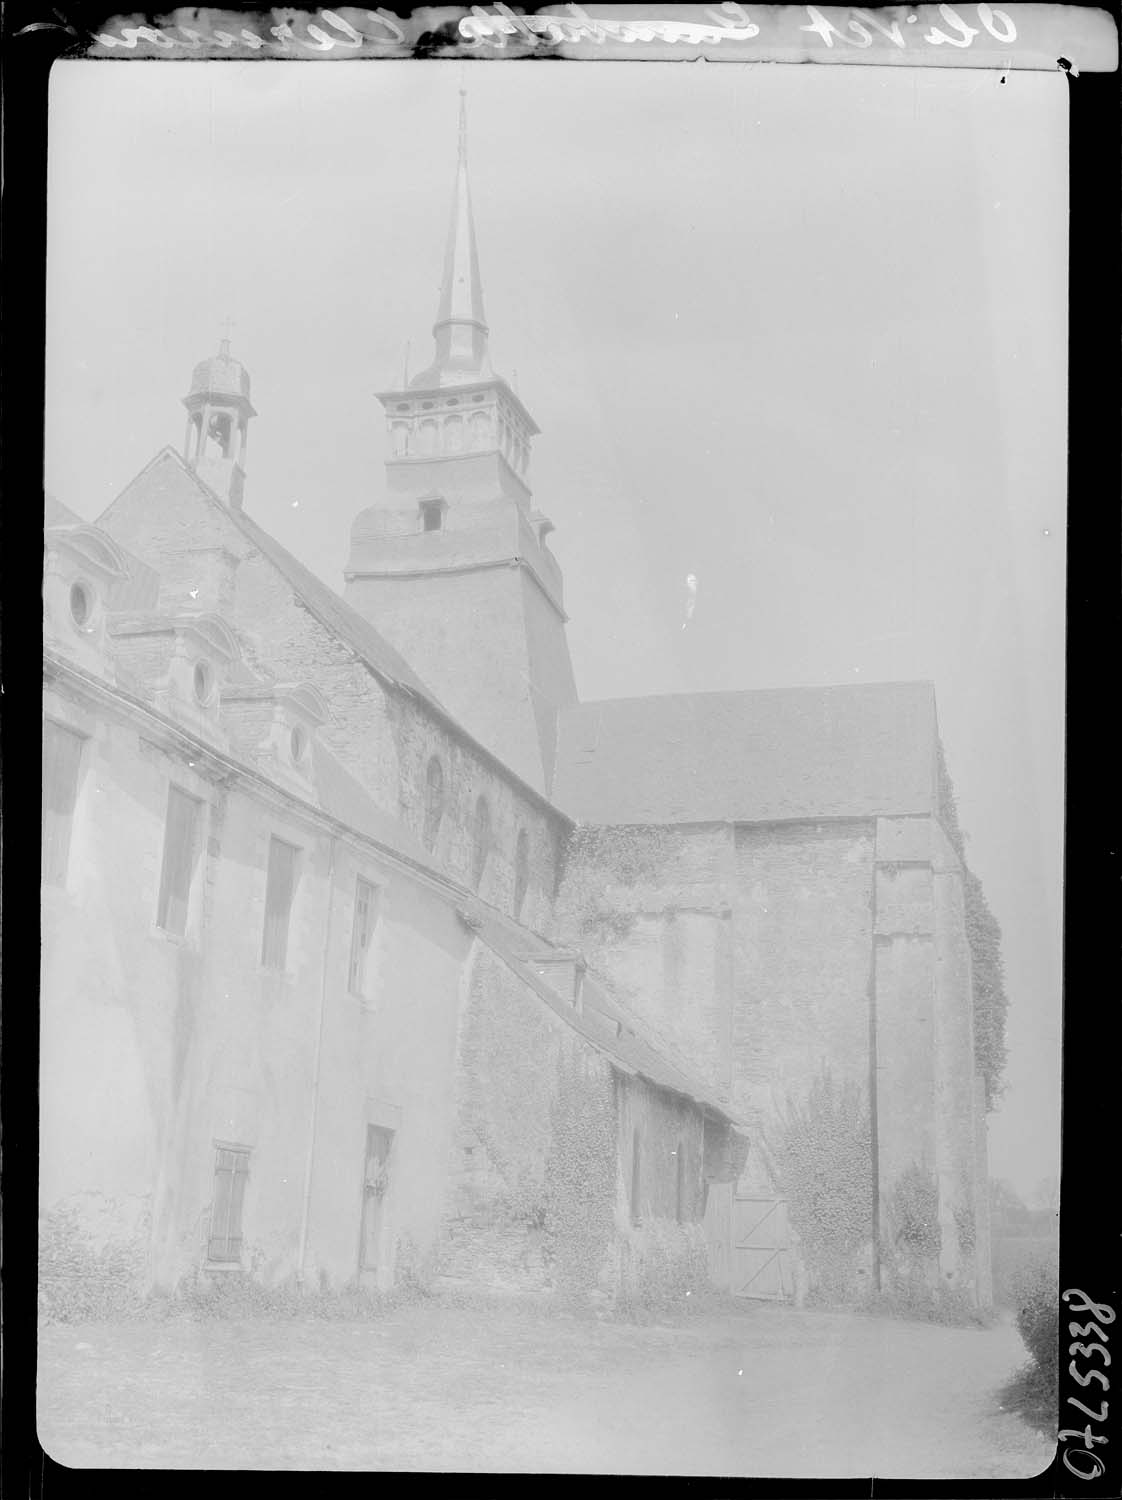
[41,663,468,1286]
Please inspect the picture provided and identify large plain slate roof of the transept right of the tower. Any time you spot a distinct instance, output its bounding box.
[554,683,936,825]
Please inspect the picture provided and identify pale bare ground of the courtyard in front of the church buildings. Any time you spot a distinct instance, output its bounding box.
[38,1305,1055,1479]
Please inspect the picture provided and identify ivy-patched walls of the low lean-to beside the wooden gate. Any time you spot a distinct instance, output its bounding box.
[438,947,720,1301]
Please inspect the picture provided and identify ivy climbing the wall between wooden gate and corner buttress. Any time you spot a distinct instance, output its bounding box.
[767,1068,873,1296]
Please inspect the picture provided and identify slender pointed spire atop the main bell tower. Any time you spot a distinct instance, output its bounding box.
[413,89,492,387]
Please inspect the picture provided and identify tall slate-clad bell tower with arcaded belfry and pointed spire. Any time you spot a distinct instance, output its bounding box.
[345,92,576,791]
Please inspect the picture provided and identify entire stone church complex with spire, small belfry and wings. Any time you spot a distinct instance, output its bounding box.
[41,105,989,1302]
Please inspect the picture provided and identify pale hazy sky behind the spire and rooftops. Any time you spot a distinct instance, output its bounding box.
[47,62,1067,1193]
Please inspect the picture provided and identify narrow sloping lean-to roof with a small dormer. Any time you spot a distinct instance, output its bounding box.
[473,909,746,1131]
